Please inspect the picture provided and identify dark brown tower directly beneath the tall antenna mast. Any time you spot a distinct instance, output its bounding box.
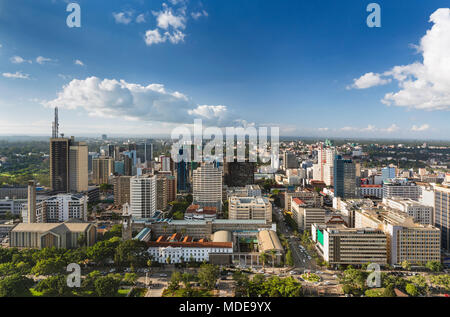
[50,137,70,193]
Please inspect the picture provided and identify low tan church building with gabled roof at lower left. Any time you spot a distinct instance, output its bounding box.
[9,221,97,249]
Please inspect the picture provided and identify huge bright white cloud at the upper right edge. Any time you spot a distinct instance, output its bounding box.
[354,8,450,110]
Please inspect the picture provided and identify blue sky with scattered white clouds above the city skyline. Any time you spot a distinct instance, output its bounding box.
[0,0,450,139]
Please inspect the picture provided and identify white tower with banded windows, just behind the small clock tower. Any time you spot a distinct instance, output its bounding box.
[130,174,156,218]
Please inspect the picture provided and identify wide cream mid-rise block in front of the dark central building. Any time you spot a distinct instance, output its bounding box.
[228,196,272,223]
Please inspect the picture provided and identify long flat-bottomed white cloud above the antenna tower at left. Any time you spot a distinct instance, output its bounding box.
[42,77,241,126]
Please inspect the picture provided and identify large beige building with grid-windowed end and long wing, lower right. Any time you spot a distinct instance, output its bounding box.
[355,209,441,265]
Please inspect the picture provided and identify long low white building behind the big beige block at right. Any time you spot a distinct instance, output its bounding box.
[383,198,434,225]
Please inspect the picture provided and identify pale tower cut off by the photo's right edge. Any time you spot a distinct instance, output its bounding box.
[434,184,450,252]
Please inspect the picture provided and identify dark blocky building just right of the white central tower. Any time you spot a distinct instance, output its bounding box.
[223,160,255,187]
